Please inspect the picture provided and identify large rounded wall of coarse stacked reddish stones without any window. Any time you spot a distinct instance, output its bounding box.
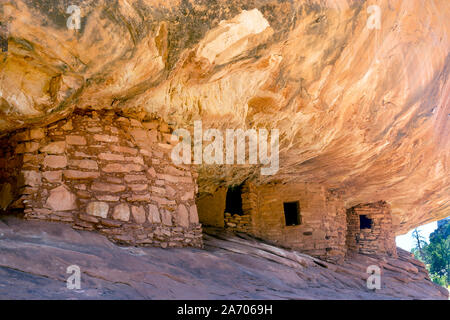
[8,111,202,247]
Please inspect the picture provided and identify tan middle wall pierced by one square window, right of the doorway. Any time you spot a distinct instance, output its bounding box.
[248,183,347,261]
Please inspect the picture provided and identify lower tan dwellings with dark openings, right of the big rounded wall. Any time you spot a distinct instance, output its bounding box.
[197,183,396,261]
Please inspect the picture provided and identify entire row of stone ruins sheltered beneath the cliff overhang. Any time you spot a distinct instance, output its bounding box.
[0,110,396,261]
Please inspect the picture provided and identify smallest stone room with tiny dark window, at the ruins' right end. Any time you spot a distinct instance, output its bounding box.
[346,201,397,257]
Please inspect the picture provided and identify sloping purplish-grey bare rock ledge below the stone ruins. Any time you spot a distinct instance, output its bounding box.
[0,216,448,300]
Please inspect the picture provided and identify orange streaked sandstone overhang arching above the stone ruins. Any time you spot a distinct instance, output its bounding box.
[0,0,450,234]
